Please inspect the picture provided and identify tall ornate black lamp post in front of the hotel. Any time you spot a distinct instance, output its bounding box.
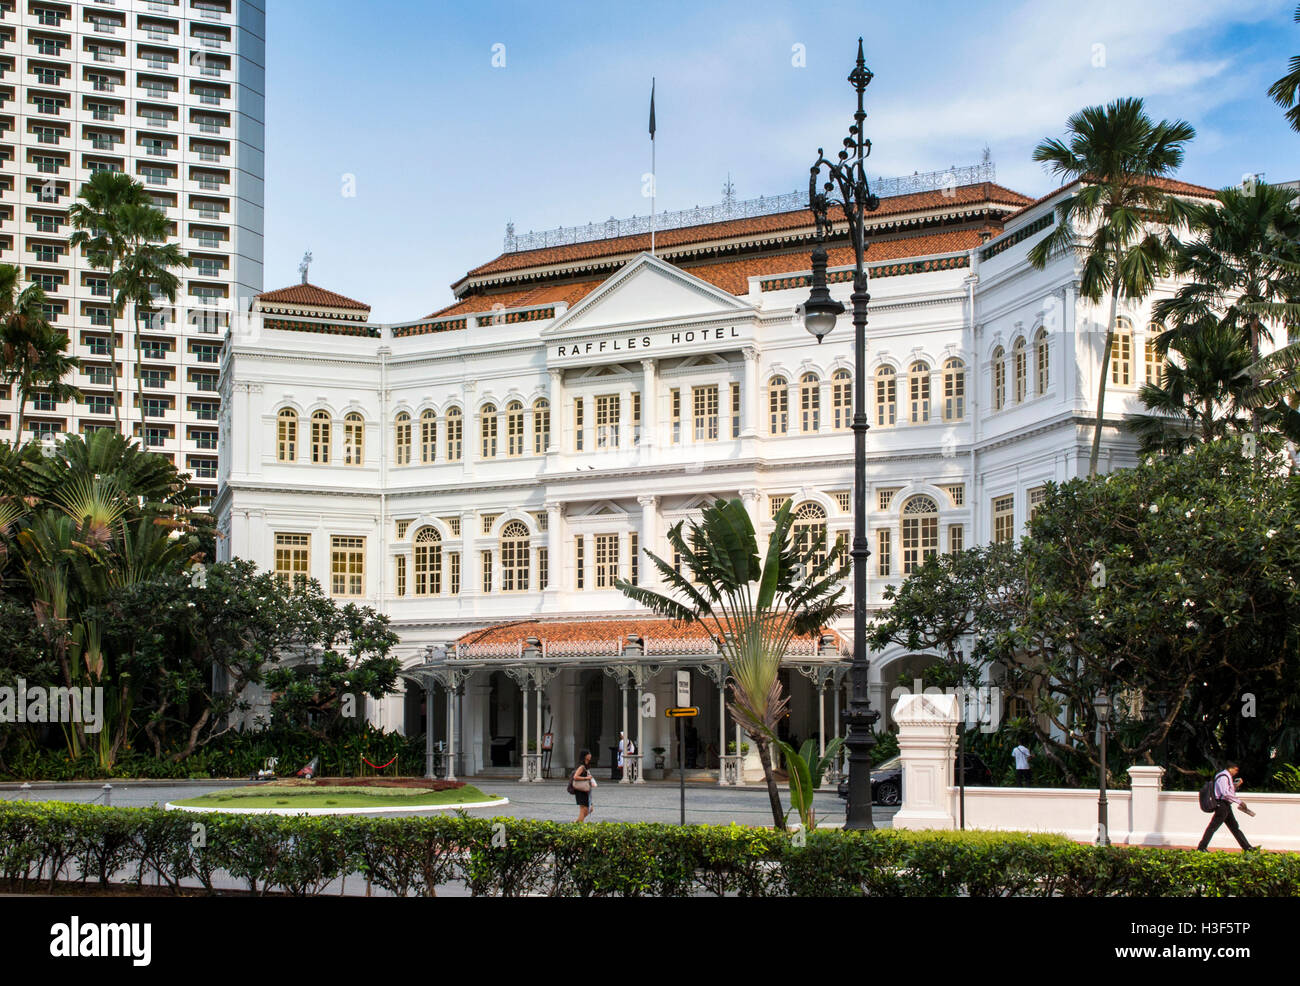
[801,38,880,829]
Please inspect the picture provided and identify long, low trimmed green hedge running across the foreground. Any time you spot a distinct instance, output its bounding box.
[0,801,1300,898]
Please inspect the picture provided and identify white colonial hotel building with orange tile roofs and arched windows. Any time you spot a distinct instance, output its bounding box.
[216,165,1212,778]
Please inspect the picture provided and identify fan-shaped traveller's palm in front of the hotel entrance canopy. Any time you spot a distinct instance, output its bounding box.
[615,498,848,830]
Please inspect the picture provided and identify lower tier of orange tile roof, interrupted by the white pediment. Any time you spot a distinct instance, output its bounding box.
[426,226,1001,319]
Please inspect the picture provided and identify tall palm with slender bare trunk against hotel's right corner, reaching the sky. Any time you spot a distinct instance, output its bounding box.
[1028,99,1196,476]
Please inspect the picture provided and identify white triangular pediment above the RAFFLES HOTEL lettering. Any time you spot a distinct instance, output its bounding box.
[542,254,753,336]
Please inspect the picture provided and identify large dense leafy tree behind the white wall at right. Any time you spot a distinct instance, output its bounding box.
[989,438,1300,779]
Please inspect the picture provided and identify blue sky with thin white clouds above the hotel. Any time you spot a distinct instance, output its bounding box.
[265,0,1300,321]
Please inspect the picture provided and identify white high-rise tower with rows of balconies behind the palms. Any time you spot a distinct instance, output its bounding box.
[0,0,265,498]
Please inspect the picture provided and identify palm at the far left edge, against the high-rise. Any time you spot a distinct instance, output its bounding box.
[0,264,79,445]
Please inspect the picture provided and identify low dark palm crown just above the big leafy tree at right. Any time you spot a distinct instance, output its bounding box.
[1127,317,1255,454]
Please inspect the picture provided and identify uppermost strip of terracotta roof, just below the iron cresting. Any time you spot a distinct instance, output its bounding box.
[465,182,1030,277]
